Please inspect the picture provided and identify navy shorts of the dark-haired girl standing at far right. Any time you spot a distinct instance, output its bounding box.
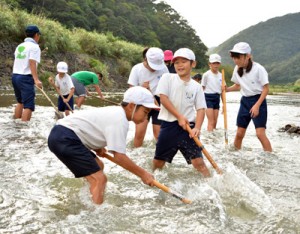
[236,94,268,128]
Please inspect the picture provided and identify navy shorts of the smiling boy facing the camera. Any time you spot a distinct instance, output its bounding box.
[154,121,203,164]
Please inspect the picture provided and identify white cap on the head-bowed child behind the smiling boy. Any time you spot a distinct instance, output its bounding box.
[146,47,166,71]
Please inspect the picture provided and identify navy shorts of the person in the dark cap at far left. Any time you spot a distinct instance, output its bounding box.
[12,74,35,111]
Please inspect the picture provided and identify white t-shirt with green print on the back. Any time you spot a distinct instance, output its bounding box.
[13,37,41,75]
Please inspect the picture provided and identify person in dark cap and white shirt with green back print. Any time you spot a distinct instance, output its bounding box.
[12,25,42,121]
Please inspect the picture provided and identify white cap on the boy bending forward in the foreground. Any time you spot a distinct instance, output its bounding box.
[123,86,160,109]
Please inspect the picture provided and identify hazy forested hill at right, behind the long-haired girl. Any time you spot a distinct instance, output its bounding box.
[214,13,300,84]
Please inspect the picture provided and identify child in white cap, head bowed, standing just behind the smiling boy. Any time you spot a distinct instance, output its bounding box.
[127,47,169,147]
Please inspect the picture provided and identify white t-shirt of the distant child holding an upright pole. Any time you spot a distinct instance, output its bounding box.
[201,70,222,94]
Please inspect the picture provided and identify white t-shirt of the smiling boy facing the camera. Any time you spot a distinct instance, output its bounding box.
[156,73,206,122]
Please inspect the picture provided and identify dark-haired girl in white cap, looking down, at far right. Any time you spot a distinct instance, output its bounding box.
[226,42,272,152]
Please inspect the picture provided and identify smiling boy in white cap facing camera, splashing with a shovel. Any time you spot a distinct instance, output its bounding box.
[153,48,210,177]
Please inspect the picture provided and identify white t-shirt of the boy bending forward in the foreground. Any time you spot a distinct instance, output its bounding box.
[57,106,129,154]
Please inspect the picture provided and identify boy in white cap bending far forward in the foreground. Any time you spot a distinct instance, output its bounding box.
[48,87,159,204]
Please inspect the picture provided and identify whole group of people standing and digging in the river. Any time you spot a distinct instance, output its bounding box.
[12,25,272,204]
